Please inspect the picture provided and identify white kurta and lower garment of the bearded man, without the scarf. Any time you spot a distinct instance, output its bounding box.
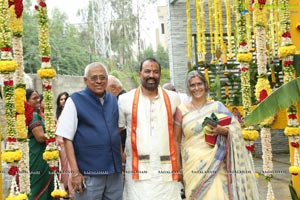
[119,57,181,200]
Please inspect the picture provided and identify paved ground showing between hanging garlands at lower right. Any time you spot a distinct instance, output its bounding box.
[253,154,292,200]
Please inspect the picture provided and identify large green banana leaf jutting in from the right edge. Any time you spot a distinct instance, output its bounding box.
[244,77,300,126]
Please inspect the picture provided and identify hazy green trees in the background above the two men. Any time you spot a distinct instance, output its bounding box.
[23,0,169,76]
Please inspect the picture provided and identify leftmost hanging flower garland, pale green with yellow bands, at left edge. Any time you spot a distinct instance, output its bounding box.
[0,0,23,199]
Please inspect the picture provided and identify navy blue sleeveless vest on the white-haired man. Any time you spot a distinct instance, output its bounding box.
[71,87,122,176]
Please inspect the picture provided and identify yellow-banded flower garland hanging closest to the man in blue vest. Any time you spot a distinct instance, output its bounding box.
[35,0,67,198]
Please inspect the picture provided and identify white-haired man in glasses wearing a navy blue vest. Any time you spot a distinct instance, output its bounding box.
[56,62,123,200]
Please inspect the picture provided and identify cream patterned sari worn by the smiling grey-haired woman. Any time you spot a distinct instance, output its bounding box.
[175,101,259,200]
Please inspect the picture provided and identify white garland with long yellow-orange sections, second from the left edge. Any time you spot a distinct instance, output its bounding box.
[8,0,30,196]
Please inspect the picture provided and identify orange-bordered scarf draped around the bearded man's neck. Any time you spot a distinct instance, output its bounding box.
[131,87,179,180]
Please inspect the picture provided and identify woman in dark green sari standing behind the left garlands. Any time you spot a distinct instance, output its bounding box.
[25,89,54,200]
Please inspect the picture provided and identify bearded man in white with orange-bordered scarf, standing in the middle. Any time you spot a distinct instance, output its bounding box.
[119,58,181,200]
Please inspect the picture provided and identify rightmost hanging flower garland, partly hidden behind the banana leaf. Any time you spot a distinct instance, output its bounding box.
[278,0,300,176]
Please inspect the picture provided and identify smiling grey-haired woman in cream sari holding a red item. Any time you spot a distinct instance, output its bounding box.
[174,71,259,200]
